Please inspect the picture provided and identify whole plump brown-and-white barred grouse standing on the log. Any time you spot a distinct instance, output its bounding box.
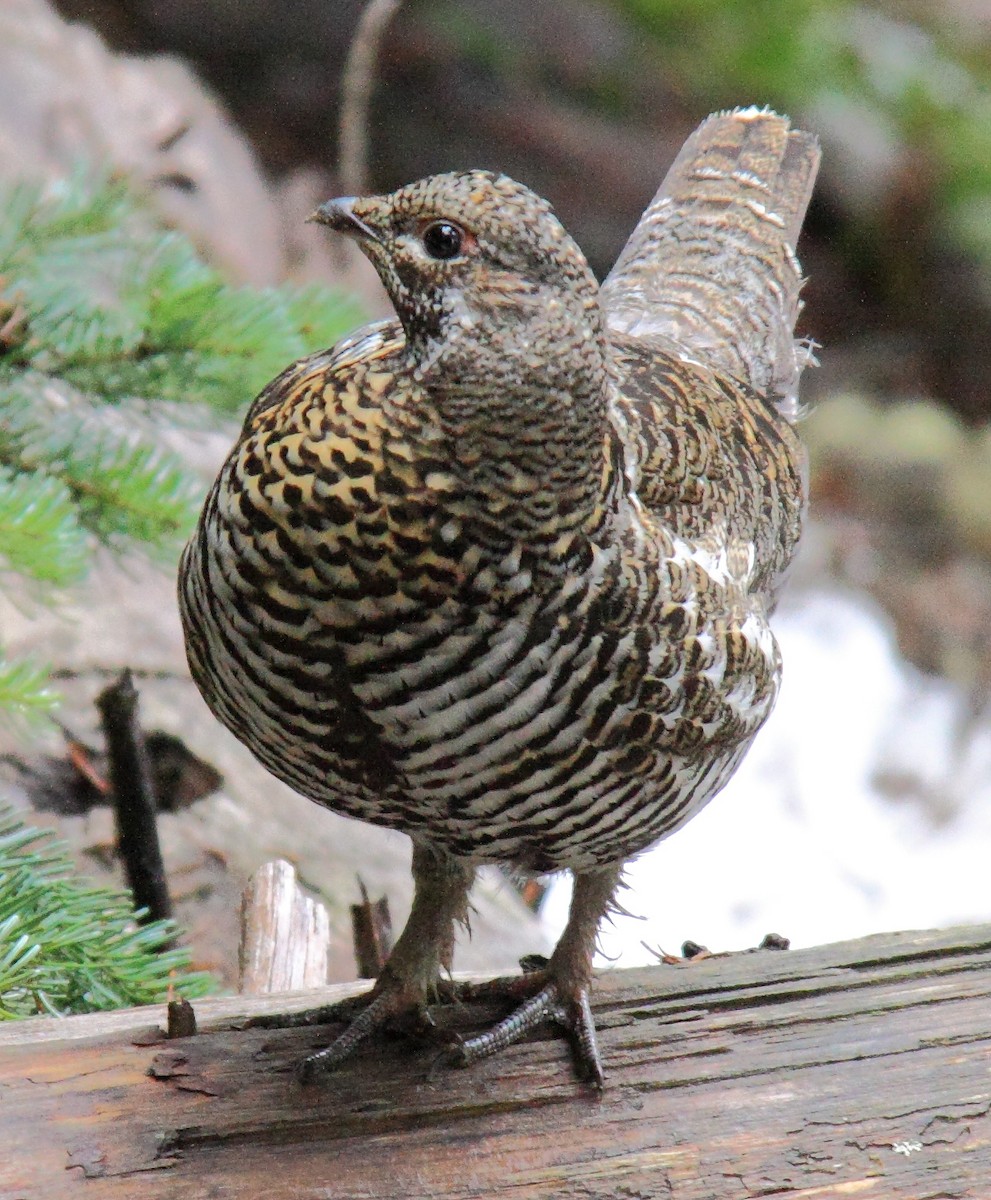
[180,109,817,1082]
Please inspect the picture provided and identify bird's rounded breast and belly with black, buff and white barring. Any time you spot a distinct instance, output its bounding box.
[177,348,777,869]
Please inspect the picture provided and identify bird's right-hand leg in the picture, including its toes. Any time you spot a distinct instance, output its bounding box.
[451,865,621,1087]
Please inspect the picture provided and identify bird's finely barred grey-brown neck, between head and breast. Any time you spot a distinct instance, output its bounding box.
[405,296,606,550]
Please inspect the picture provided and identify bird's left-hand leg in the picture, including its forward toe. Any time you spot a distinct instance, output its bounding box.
[300,842,475,1079]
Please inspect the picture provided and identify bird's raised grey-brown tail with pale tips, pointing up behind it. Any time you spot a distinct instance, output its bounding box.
[601,108,819,418]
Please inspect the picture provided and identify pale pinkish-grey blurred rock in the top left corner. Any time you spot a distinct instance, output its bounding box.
[0,0,283,284]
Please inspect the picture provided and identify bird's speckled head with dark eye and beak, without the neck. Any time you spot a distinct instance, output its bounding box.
[312,170,601,385]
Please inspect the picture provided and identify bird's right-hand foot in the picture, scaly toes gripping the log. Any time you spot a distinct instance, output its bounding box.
[443,961,597,1088]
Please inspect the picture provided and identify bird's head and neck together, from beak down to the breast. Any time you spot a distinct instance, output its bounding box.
[313,170,607,544]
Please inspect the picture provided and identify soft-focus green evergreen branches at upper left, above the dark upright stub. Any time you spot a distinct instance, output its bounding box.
[0,173,361,718]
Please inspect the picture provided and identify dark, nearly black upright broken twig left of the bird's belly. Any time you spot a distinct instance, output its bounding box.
[96,670,172,931]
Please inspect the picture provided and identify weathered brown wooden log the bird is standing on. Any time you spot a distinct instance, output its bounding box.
[0,926,991,1200]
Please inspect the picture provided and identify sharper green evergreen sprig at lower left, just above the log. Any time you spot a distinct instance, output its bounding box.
[0,808,214,1020]
